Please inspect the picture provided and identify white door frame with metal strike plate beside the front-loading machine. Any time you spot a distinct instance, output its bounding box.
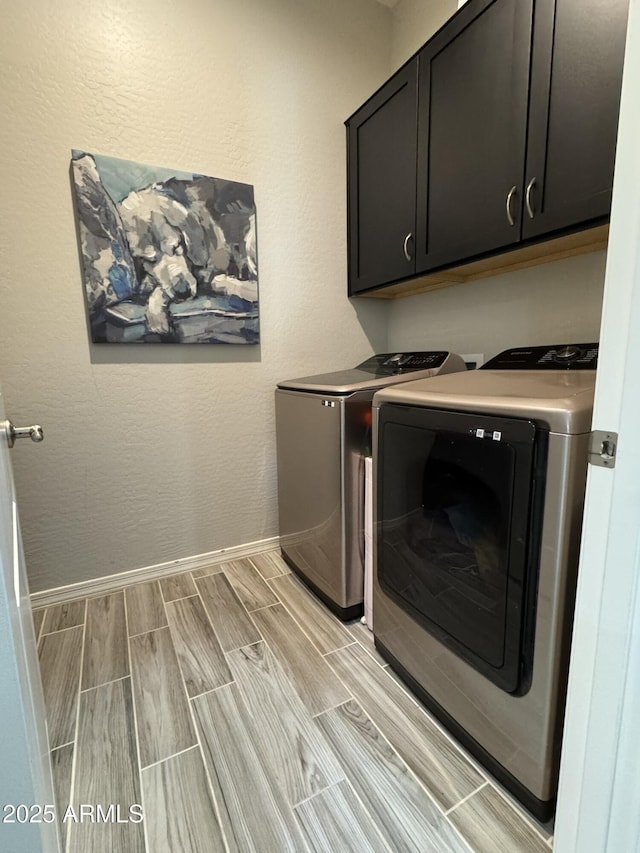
[554,0,640,853]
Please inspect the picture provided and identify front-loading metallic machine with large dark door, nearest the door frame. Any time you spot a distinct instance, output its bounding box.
[373,343,598,820]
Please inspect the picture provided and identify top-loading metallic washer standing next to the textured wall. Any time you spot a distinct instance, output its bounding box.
[275,351,466,620]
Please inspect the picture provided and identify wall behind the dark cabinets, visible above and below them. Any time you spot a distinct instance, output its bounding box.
[388,0,604,358]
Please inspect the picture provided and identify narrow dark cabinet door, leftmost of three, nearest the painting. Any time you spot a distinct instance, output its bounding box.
[347,59,418,295]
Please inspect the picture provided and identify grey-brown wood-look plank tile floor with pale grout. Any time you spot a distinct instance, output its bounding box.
[34,551,552,853]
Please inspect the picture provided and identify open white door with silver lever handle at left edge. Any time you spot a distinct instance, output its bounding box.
[0,389,60,853]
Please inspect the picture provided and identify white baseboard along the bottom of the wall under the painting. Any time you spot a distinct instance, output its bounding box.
[30,536,280,609]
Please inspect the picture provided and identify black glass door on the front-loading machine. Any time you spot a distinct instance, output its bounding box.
[374,404,544,693]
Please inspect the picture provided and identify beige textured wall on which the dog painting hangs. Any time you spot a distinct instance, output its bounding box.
[0,0,391,591]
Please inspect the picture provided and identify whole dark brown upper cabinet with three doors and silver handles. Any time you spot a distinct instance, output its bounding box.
[347,0,628,296]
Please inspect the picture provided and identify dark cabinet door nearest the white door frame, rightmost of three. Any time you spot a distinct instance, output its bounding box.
[523,0,628,237]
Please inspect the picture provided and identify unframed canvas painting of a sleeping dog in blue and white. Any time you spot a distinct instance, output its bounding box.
[71,151,260,344]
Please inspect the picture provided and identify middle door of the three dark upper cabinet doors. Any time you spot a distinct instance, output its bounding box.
[416,0,533,272]
